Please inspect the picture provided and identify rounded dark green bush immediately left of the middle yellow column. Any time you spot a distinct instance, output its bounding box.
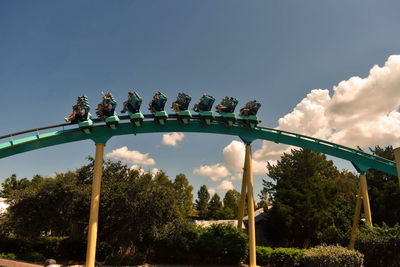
[193,224,248,264]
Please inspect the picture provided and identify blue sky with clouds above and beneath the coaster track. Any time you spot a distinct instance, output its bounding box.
[0,0,400,201]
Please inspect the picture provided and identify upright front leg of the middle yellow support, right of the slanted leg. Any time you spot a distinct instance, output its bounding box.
[245,144,257,267]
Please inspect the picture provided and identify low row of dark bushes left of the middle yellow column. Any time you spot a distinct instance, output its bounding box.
[0,224,248,265]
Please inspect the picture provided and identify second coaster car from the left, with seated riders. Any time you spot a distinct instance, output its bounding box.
[96,93,119,129]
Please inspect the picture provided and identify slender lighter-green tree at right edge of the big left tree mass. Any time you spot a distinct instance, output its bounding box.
[173,173,193,216]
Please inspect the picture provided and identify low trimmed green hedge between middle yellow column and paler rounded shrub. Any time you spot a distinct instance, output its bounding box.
[256,247,305,267]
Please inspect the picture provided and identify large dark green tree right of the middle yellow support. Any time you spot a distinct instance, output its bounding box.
[264,149,357,247]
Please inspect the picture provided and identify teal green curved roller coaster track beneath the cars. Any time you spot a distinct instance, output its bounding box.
[0,115,397,176]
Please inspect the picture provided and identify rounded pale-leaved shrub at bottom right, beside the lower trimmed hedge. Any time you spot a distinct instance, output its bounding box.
[304,246,364,267]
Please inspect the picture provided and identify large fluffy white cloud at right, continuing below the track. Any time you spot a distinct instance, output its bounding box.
[195,55,400,177]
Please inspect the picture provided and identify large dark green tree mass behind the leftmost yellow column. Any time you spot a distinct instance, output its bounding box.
[0,158,192,259]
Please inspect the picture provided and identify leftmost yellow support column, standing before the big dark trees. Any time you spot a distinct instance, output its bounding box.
[85,143,105,267]
